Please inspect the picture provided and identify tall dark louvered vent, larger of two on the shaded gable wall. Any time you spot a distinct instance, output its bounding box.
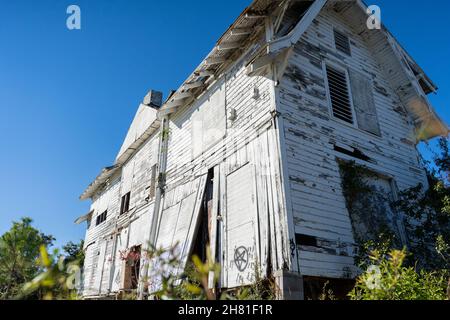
[327,66,353,124]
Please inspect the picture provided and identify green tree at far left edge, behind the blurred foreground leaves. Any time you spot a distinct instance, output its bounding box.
[0,218,55,299]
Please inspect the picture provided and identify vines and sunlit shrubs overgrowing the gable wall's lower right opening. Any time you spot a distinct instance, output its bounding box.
[340,139,450,300]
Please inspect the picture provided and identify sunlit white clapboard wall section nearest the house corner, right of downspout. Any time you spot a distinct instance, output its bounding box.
[160,35,290,287]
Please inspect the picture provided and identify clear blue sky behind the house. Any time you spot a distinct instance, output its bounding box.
[0,0,450,245]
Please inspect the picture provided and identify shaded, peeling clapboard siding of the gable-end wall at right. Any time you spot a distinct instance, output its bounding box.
[277,10,426,278]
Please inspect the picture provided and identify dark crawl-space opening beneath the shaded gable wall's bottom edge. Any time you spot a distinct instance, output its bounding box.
[303,277,355,300]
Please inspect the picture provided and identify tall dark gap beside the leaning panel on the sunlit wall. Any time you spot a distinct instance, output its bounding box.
[192,169,214,262]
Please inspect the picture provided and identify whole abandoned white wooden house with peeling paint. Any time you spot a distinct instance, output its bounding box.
[77,0,449,298]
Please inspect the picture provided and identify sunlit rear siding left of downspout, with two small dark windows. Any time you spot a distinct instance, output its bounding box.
[84,133,159,296]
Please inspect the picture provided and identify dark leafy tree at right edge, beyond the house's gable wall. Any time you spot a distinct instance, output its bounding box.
[394,138,450,270]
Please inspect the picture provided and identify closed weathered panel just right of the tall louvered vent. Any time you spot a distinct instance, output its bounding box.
[349,70,381,136]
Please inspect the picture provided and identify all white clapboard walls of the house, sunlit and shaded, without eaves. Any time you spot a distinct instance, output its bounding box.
[80,0,436,295]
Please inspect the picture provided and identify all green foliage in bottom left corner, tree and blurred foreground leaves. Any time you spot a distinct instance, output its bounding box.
[0,218,84,300]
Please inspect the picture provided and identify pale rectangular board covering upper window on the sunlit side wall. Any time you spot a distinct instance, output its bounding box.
[191,81,226,158]
